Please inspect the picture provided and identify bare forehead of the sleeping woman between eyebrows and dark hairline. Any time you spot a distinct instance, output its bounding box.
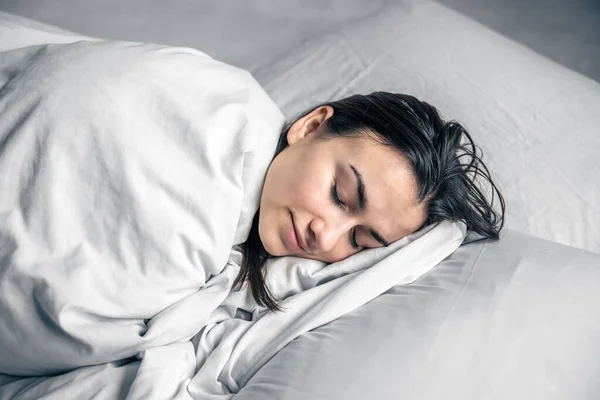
[322,135,425,241]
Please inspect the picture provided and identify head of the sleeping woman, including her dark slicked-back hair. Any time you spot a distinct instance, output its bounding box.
[236,92,505,310]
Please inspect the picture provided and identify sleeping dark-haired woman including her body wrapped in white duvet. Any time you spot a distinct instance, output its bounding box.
[0,41,504,375]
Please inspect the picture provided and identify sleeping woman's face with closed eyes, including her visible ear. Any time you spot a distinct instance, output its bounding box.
[259,106,425,262]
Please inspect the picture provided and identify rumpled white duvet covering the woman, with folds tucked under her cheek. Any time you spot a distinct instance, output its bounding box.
[0,36,465,399]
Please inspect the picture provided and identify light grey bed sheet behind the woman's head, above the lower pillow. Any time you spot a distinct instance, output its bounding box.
[2,0,600,252]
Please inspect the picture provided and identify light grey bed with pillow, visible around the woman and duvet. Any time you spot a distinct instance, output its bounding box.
[0,0,600,400]
